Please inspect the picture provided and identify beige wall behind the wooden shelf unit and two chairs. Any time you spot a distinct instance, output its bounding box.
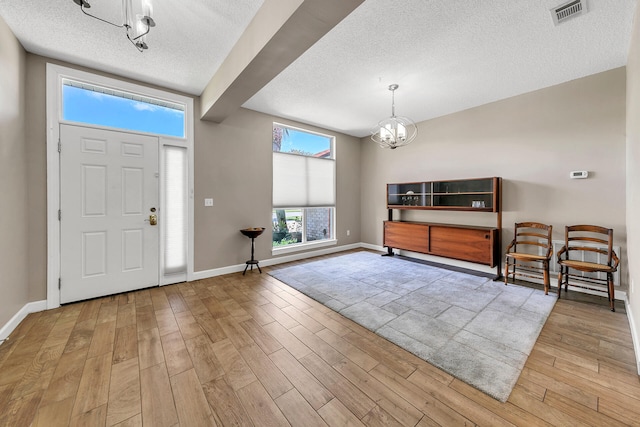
[361,67,627,284]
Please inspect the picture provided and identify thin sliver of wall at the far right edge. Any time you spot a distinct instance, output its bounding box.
[627,7,640,373]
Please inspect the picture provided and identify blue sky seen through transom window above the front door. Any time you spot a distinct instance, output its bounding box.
[62,85,185,138]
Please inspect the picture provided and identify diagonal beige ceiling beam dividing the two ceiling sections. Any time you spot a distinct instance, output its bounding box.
[200,0,364,123]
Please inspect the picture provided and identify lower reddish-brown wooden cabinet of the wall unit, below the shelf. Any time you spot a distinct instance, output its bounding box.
[384,221,499,267]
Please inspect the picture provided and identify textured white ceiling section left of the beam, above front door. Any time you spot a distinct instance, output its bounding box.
[0,0,263,95]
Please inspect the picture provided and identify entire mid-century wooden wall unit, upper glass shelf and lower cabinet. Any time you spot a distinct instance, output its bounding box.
[383,177,502,277]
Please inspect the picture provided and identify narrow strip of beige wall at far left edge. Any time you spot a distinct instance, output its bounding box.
[0,17,31,327]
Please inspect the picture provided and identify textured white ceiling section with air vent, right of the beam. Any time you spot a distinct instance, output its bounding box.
[244,0,636,136]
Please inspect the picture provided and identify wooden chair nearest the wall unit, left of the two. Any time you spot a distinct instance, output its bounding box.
[504,222,553,295]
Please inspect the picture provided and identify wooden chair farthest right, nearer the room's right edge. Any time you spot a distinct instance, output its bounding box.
[558,225,620,311]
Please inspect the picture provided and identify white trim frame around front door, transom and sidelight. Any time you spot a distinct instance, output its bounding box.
[46,63,194,309]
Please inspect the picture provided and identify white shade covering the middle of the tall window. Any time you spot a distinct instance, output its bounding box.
[273,152,336,208]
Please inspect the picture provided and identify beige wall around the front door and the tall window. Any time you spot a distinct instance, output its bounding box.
[20,54,360,302]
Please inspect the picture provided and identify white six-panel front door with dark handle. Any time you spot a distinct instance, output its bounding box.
[60,124,159,303]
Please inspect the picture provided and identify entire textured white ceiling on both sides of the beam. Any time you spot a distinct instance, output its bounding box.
[0,0,637,136]
